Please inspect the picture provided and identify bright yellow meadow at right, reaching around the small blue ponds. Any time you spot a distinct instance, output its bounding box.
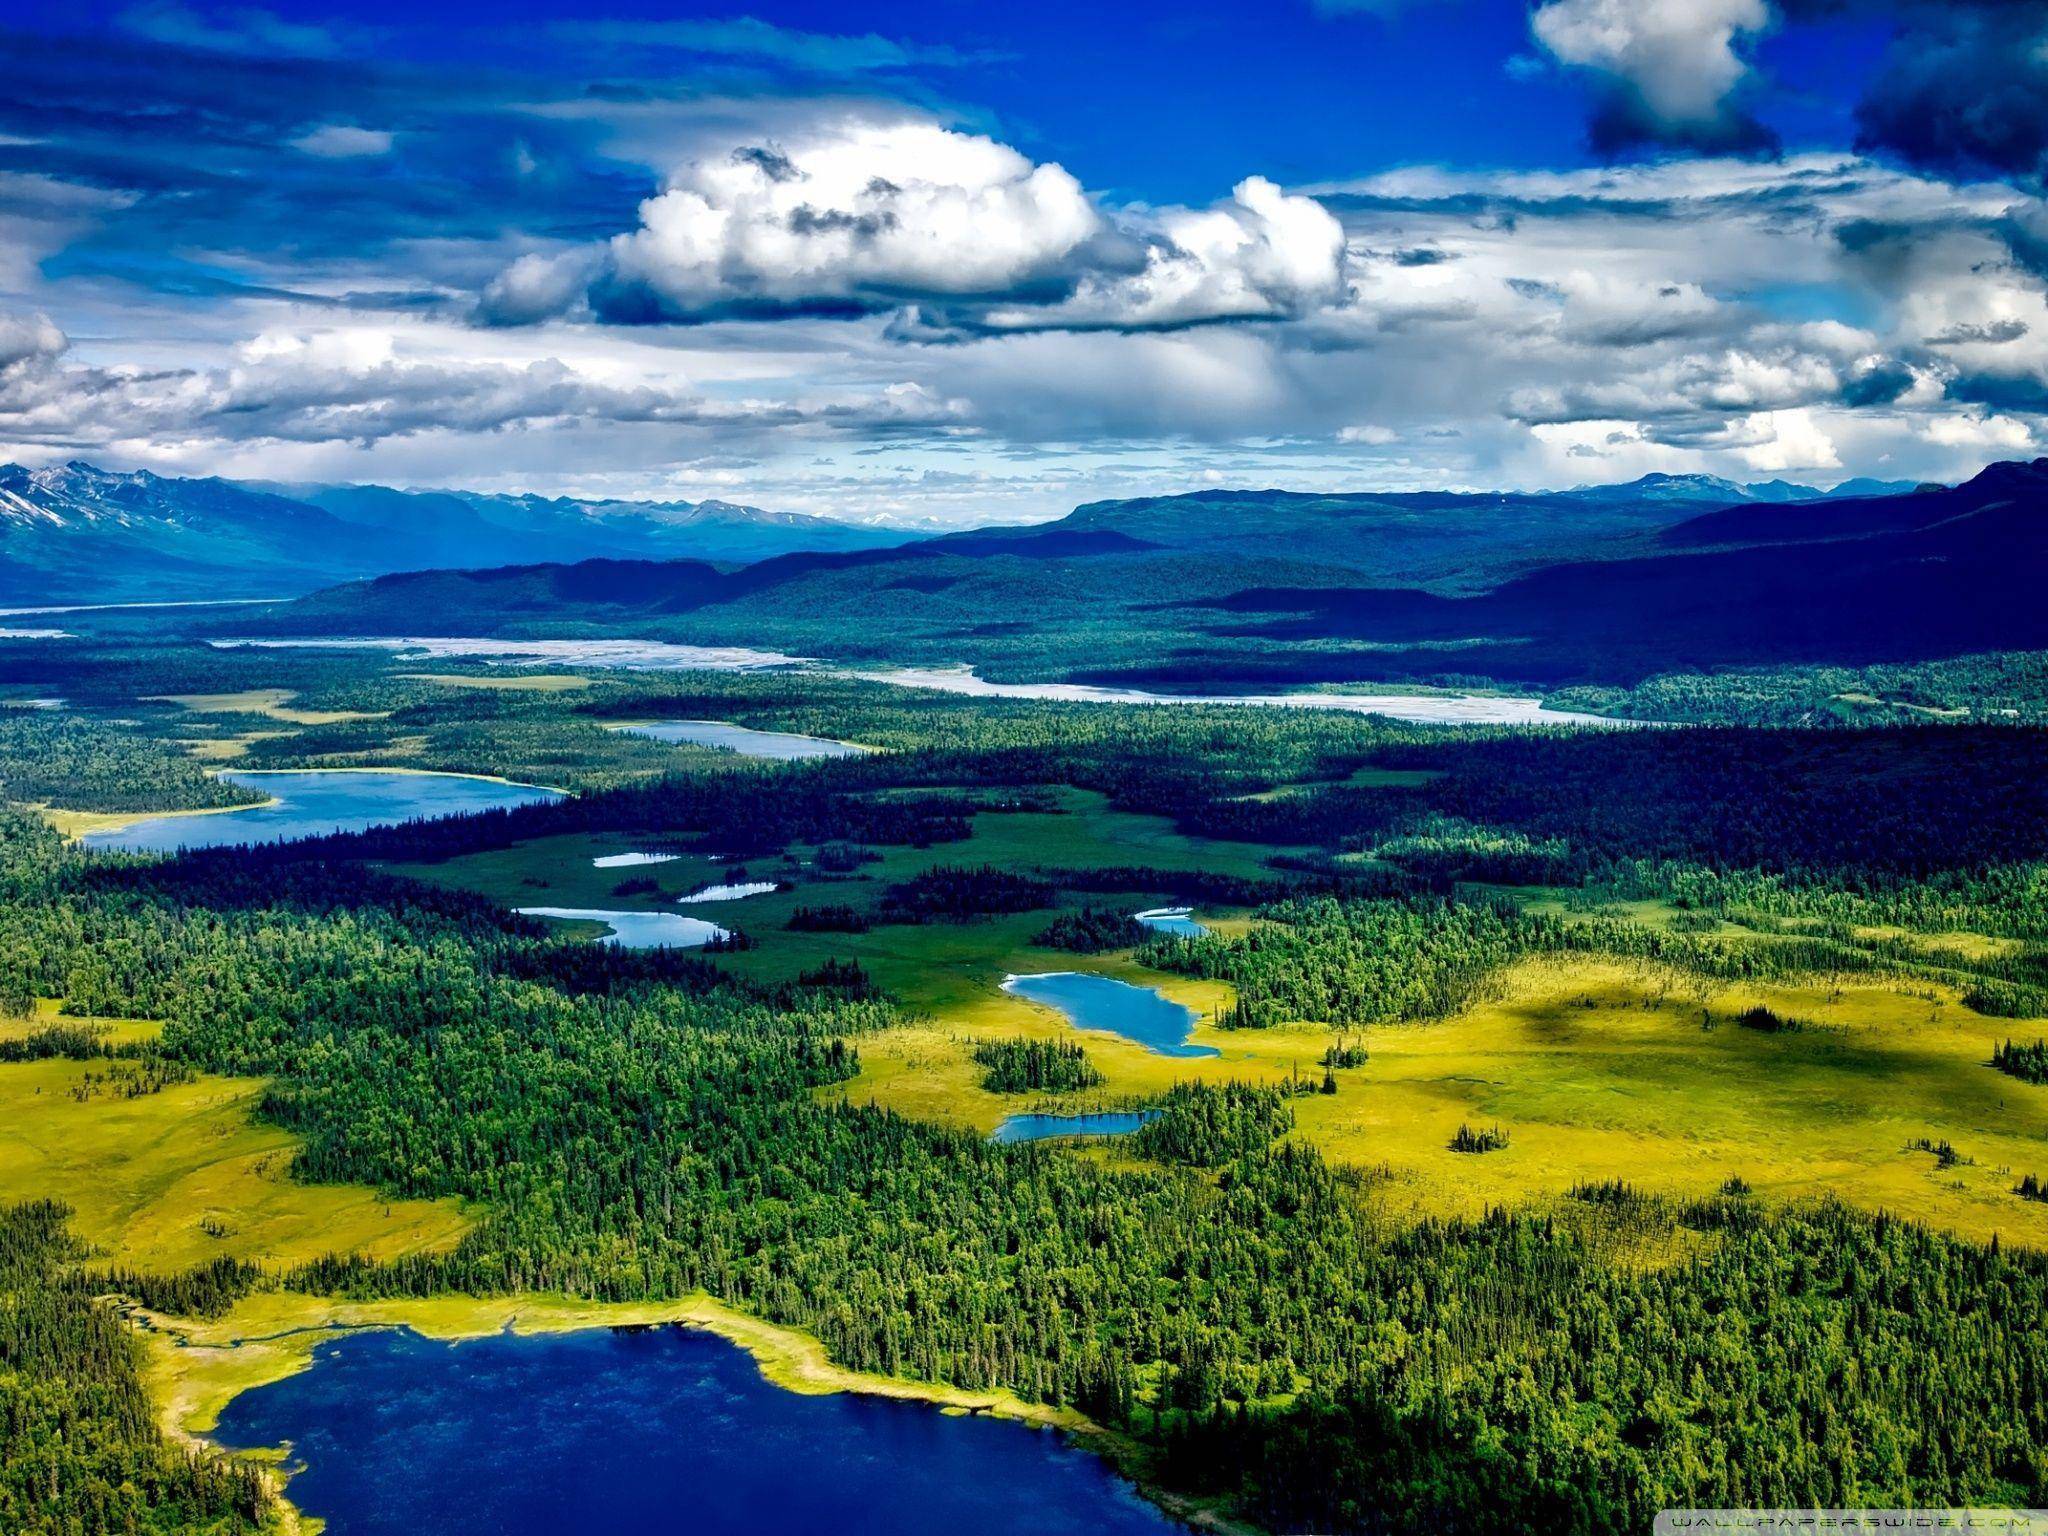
[829,950,2048,1247]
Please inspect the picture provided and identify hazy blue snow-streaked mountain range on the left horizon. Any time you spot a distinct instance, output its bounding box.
[0,461,915,602]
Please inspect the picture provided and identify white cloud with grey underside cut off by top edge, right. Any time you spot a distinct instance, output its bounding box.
[1530,0,1772,150]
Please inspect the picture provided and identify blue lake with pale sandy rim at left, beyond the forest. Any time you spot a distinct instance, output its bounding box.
[80,770,561,854]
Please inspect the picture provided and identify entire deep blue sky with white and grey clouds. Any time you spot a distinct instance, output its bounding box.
[0,0,2048,526]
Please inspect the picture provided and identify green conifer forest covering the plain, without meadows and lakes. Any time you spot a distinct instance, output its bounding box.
[0,638,2048,1534]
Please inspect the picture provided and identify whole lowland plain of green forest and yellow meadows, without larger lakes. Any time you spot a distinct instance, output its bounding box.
[0,626,2048,1532]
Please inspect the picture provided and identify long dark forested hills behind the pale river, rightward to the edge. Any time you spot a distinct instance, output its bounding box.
[242,461,2048,688]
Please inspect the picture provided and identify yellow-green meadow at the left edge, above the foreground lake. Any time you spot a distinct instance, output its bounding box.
[0,1022,471,1272]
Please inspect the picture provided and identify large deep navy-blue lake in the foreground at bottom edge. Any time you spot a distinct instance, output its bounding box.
[215,1327,1182,1536]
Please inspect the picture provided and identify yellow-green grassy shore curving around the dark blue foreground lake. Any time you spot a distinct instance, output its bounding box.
[140,1292,1260,1536]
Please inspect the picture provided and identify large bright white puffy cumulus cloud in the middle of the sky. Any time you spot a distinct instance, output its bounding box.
[479,121,1343,336]
